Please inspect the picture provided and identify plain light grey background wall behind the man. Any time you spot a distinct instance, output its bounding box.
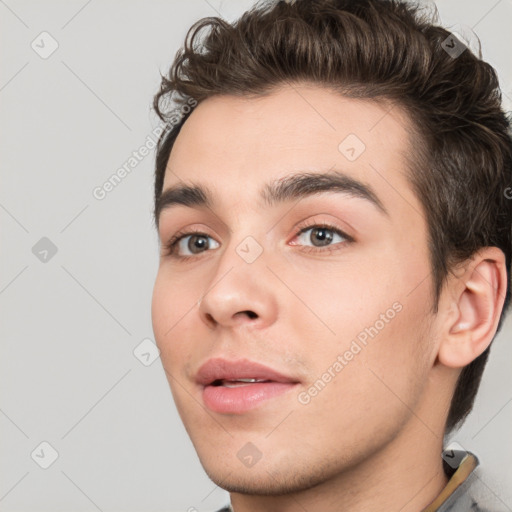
[0,0,512,512]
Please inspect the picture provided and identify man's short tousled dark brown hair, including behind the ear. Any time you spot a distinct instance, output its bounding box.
[154,0,512,432]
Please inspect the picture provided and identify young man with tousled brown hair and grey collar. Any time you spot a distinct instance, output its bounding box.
[152,0,512,512]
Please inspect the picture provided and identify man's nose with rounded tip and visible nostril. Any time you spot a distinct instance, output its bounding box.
[199,239,278,328]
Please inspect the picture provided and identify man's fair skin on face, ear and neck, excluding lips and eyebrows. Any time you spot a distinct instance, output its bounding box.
[152,83,505,512]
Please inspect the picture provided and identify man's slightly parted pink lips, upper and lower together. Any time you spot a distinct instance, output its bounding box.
[196,358,299,414]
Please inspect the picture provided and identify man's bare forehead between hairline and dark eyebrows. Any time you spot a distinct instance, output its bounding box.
[163,85,420,218]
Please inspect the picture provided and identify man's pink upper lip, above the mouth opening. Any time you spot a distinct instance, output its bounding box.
[196,358,298,386]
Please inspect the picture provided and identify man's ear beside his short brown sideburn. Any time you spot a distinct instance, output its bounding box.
[438,247,507,368]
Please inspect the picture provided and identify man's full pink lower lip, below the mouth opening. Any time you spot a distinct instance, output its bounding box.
[203,382,296,414]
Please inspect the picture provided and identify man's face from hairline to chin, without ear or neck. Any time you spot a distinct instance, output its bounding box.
[152,84,435,494]
